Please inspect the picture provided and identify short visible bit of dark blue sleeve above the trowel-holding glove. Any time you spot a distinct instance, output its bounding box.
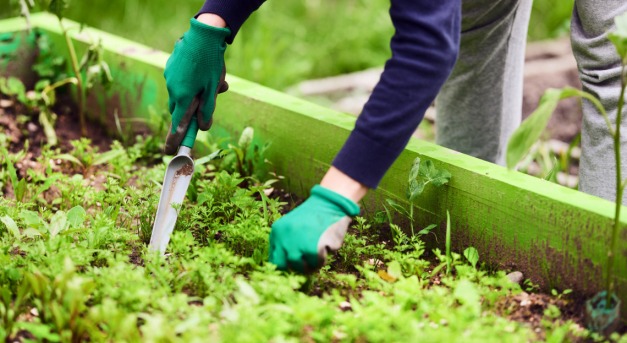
[196,0,265,43]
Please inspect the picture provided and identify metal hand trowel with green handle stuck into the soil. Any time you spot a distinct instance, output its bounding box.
[149,101,198,254]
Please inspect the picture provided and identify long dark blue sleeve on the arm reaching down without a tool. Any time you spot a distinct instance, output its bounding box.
[333,0,461,188]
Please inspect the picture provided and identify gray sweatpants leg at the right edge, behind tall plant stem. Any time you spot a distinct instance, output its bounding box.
[571,0,627,204]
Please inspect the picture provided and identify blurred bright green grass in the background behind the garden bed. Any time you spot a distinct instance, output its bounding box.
[0,0,573,90]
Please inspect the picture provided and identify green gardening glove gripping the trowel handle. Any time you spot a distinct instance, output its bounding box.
[163,18,231,154]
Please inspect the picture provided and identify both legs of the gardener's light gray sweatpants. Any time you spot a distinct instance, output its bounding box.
[436,0,627,203]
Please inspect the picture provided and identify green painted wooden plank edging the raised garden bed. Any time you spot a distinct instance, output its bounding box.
[0,15,627,316]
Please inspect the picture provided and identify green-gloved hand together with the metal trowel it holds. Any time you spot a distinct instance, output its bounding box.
[150,14,231,253]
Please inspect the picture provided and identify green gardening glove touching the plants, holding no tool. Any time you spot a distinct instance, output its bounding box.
[270,185,359,273]
